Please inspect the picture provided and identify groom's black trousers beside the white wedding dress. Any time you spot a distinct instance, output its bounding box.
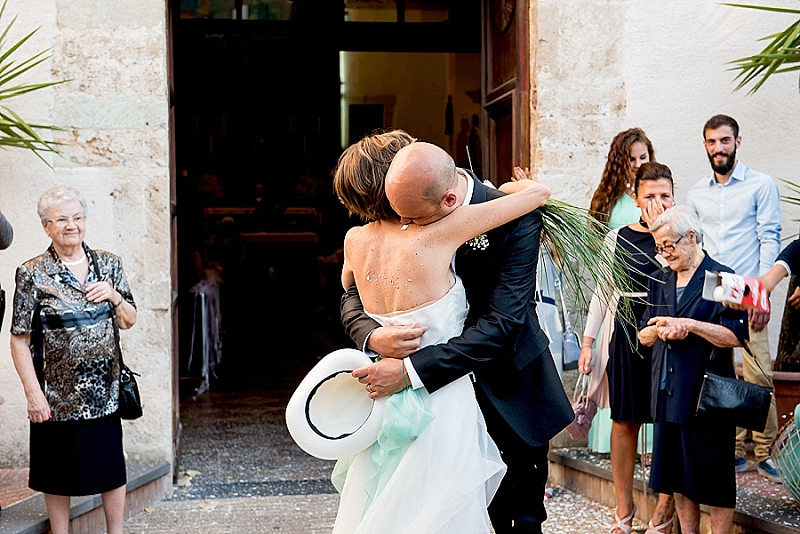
[475,385,550,534]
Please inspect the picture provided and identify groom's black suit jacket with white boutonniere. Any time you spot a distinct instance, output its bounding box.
[340,176,574,446]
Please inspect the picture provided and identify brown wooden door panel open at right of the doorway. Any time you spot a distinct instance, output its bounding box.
[482,0,531,185]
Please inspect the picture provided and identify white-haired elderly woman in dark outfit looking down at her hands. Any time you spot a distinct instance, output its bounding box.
[639,206,748,534]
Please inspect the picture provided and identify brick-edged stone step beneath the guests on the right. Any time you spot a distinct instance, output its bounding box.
[550,447,800,534]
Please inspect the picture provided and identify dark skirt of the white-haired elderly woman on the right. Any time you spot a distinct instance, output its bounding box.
[650,390,736,508]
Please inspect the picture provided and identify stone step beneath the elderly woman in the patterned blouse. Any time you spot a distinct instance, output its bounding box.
[0,462,172,534]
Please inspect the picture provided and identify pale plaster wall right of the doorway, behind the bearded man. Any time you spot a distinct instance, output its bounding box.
[531,0,800,357]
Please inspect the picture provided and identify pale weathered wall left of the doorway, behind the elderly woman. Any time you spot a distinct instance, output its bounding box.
[0,0,172,467]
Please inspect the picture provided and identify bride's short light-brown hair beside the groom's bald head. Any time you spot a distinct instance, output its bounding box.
[333,130,416,221]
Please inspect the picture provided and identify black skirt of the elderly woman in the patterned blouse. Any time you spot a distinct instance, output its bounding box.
[28,414,127,496]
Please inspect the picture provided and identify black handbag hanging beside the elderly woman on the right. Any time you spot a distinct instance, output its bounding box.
[697,339,774,432]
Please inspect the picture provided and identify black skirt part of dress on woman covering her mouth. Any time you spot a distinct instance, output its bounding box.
[606,304,653,423]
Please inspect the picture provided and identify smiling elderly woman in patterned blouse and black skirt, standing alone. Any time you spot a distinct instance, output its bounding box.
[11,187,136,534]
